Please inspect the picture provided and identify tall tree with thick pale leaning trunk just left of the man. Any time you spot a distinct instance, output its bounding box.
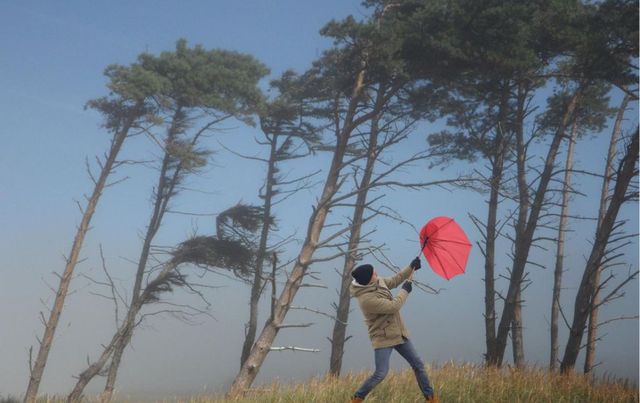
[229,17,418,396]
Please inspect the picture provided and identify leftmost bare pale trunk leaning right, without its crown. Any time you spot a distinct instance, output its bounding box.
[24,103,141,403]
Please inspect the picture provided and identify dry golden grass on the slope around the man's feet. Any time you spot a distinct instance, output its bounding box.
[7,364,638,403]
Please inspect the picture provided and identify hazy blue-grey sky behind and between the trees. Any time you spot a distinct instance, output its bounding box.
[0,0,638,395]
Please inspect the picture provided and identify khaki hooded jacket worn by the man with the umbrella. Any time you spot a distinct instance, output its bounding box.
[349,267,412,349]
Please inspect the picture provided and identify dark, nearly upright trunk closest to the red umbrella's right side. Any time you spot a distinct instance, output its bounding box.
[484,81,509,360]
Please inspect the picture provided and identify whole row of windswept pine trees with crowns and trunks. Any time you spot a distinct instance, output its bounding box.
[24,0,638,402]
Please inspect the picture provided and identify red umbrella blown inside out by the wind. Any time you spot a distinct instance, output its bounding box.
[420,217,471,280]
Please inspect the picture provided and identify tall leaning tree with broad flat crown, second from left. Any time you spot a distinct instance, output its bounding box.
[63,40,267,401]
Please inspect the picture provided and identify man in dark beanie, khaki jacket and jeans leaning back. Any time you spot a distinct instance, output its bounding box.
[349,257,439,403]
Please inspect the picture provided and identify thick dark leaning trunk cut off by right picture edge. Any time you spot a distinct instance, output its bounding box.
[560,127,638,373]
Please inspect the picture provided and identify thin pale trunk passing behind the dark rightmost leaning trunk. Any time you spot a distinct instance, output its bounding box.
[584,95,630,374]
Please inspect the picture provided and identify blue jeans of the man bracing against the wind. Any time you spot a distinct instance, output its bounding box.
[354,337,433,399]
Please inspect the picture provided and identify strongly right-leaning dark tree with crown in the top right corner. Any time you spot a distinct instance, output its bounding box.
[490,1,637,365]
